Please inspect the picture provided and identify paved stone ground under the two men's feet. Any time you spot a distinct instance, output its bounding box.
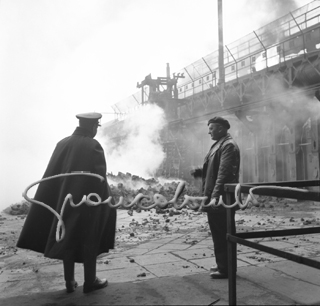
[0,211,320,306]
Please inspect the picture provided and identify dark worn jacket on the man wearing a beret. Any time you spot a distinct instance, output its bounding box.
[202,134,240,210]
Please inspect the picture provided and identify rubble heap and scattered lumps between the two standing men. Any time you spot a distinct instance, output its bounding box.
[107,172,209,249]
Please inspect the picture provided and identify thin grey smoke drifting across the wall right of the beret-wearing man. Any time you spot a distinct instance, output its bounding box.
[234,77,320,155]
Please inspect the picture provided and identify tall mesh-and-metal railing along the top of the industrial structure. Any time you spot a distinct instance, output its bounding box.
[109,1,320,114]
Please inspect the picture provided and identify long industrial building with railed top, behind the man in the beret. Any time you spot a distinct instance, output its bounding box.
[105,1,320,188]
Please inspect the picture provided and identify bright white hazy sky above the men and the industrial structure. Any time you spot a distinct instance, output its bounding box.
[0,0,311,211]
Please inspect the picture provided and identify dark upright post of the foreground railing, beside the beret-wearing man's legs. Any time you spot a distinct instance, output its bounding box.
[226,192,237,305]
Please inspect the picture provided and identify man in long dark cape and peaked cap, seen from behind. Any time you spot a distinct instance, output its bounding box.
[17,113,116,293]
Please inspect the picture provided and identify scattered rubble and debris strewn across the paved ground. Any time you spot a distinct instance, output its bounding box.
[0,173,320,277]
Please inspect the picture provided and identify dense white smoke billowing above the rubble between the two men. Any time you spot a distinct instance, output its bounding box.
[98,104,166,178]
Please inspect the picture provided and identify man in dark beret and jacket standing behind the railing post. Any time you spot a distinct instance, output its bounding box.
[191,117,240,278]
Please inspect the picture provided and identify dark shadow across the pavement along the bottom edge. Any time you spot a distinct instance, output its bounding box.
[0,273,293,306]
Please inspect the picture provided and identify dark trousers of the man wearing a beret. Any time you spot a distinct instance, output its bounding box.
[207,208,235,274]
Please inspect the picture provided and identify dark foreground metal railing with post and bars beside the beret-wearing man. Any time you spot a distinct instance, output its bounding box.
[225,180,320,305]
